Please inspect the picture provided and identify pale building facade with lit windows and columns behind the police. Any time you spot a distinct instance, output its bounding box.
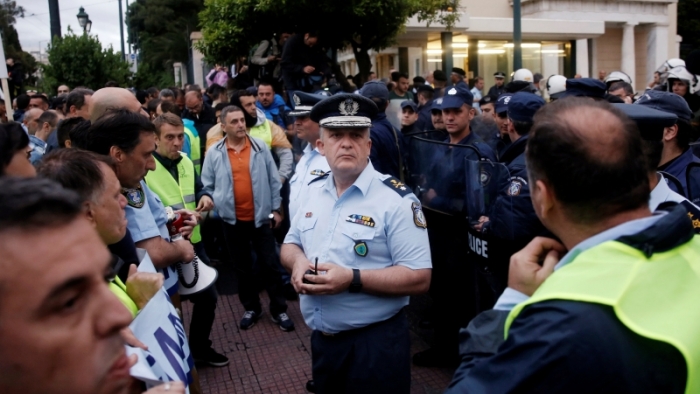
[338,0,681,90]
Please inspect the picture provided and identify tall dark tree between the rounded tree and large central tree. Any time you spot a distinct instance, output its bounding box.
[126,0,204,86]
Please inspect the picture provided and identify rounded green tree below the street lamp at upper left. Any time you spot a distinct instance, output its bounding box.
[43,27,131,92]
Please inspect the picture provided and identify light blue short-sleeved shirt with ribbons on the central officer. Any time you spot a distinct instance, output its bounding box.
[284,163,432,333]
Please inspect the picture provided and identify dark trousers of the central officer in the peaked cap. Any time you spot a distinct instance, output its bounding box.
[311,309,411,394]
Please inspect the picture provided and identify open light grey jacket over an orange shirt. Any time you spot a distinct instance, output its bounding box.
[202,136,282,227]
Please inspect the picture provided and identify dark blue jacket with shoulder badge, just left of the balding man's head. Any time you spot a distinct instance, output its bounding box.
[483,135,546,242]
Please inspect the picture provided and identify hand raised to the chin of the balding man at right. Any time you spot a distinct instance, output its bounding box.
[508,237,566,296]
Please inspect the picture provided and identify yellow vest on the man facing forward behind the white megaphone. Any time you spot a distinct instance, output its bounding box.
[146,153,202,244]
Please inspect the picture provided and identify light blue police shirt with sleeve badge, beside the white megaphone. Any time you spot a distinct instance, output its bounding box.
[126,181,179,296]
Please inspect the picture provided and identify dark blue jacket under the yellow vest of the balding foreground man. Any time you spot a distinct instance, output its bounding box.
[447,207,693,394]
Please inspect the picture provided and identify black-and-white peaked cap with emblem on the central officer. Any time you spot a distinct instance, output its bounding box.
[309,93,379,129]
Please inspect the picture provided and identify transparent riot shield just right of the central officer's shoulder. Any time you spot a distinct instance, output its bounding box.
[407,132,479,217]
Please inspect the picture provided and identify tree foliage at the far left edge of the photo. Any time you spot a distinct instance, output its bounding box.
[0,0,37,85]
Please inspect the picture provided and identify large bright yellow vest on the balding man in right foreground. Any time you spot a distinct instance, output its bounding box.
[505,239,700,393]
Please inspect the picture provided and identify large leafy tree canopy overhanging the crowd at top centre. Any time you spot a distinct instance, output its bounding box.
[198,0,458,81]
